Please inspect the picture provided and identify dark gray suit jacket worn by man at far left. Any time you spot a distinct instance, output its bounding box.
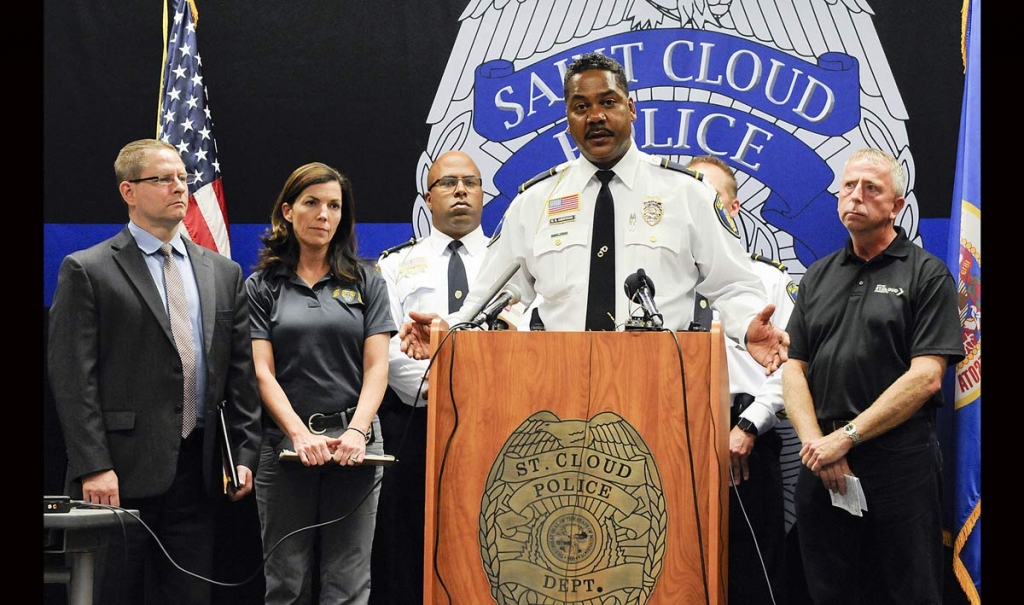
[48,227,261,499]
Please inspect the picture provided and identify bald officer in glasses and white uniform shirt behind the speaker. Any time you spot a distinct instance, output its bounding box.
[370,152,499,605]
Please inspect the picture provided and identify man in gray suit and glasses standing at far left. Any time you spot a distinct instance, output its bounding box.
[48,139,260,604]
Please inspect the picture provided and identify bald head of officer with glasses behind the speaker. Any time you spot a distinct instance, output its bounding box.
[424,150,483,240]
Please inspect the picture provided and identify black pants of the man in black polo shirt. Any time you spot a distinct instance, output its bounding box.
[796,418,943,605]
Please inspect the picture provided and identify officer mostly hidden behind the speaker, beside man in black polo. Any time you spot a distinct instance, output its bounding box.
[687,156,797,605]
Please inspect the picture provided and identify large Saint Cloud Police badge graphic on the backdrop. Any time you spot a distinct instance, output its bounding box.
[412,0,922,279]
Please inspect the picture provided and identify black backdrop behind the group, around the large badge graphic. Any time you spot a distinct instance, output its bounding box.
[43,0,964,604]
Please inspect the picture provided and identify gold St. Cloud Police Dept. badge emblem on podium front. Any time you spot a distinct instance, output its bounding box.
[479,412,669,605]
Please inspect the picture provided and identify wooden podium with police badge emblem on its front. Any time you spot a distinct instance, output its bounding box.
[424,321,729,605]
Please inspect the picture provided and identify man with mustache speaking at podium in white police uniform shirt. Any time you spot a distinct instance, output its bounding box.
[398,54,788,372]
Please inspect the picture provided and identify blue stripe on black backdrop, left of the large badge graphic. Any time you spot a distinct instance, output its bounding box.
[43,223,413,307]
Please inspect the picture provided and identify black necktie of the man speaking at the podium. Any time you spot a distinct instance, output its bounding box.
[586,170,616,330]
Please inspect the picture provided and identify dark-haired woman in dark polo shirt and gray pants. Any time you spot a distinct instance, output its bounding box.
[246,163,395,604]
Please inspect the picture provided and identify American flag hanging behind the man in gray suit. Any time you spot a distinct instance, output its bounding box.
[158,0,231,257]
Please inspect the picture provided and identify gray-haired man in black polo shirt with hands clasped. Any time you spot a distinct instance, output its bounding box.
[783,149,964,604]
